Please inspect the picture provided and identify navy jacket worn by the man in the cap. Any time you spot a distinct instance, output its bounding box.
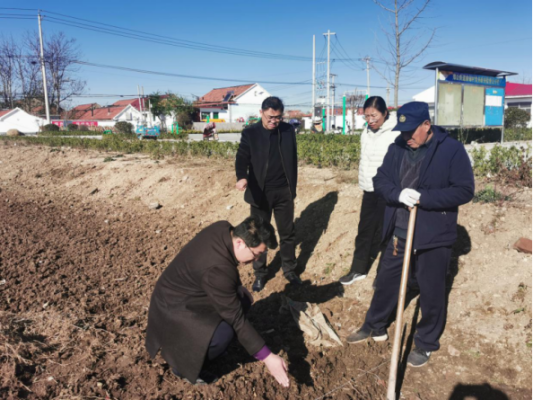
[373,126,475,250]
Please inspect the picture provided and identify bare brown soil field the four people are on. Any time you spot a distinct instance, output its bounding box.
[0,142,532,400]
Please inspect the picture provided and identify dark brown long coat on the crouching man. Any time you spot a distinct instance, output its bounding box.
[146,221,265,382]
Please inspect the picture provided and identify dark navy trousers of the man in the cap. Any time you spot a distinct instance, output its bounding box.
[362,238,452,351]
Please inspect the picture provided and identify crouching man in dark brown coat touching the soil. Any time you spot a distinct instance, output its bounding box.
[146,216,289,387]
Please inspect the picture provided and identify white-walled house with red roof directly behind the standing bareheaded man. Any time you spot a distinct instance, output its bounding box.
[193,83,271,122]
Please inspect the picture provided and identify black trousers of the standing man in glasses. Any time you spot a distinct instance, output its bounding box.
[250,187,297,278]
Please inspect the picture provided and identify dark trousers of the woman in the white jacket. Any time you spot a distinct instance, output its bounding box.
[350,192,386,275]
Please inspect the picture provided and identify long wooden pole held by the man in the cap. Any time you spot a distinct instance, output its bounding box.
[387,206,417,400]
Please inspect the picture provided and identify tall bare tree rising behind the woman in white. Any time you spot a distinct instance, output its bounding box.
[373,0,436,107]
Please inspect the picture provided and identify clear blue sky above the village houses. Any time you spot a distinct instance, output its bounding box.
[0,0,532,110]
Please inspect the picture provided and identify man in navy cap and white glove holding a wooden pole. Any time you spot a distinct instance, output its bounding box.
[347,102,475,367]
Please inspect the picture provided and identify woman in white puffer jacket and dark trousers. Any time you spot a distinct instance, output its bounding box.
[339,96,400,285]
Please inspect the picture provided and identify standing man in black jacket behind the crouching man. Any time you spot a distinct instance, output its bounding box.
[235,97,302,292]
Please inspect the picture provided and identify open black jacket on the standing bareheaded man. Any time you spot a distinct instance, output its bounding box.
[235,121,298,206]
